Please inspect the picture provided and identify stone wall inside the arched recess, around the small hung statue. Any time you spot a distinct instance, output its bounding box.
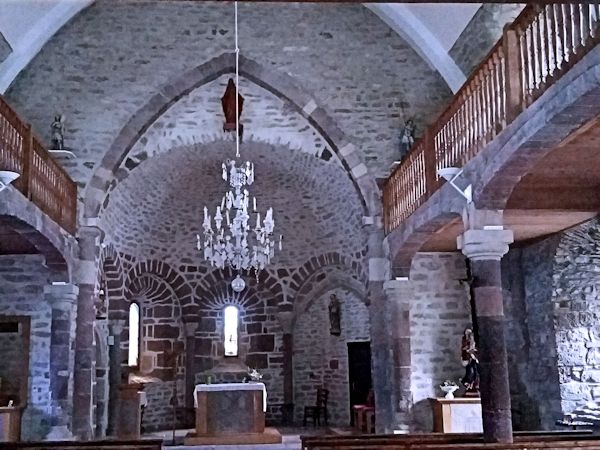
[293,287,370,426]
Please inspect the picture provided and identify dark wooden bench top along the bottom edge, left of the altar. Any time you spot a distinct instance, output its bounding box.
[0,439,163,450]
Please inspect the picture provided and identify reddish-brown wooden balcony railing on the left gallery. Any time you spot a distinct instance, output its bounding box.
[0,96,77,234]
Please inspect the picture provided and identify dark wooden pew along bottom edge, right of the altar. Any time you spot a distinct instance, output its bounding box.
[301,430,600,450]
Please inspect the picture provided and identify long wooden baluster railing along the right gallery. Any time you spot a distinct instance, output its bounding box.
[383,2,600,233]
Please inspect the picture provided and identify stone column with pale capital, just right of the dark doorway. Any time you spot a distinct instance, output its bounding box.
[383,278,413,432]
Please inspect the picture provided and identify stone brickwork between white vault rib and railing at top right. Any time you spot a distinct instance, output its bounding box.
[449,3,524,76]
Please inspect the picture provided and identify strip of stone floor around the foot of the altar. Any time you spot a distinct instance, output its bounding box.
[144,427,337,450]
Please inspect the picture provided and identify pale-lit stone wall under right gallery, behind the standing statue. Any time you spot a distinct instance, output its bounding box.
[410,253,472,431]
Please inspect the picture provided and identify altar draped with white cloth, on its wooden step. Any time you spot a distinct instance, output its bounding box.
[185,383,281,445]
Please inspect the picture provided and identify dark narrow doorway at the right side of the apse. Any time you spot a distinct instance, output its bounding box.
[348,342,372,425]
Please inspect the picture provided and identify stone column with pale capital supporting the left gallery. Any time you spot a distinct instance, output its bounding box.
[44,284,79,440]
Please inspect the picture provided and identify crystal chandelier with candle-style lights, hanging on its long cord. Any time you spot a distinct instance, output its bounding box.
[196,2,282,292]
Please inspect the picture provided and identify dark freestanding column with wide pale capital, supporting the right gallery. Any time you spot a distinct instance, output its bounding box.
[458,227,513,443]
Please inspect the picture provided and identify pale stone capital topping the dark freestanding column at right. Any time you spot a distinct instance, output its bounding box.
[456,230,514,261]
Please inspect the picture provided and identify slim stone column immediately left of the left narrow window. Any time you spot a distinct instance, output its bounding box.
[106,319,126,436]
